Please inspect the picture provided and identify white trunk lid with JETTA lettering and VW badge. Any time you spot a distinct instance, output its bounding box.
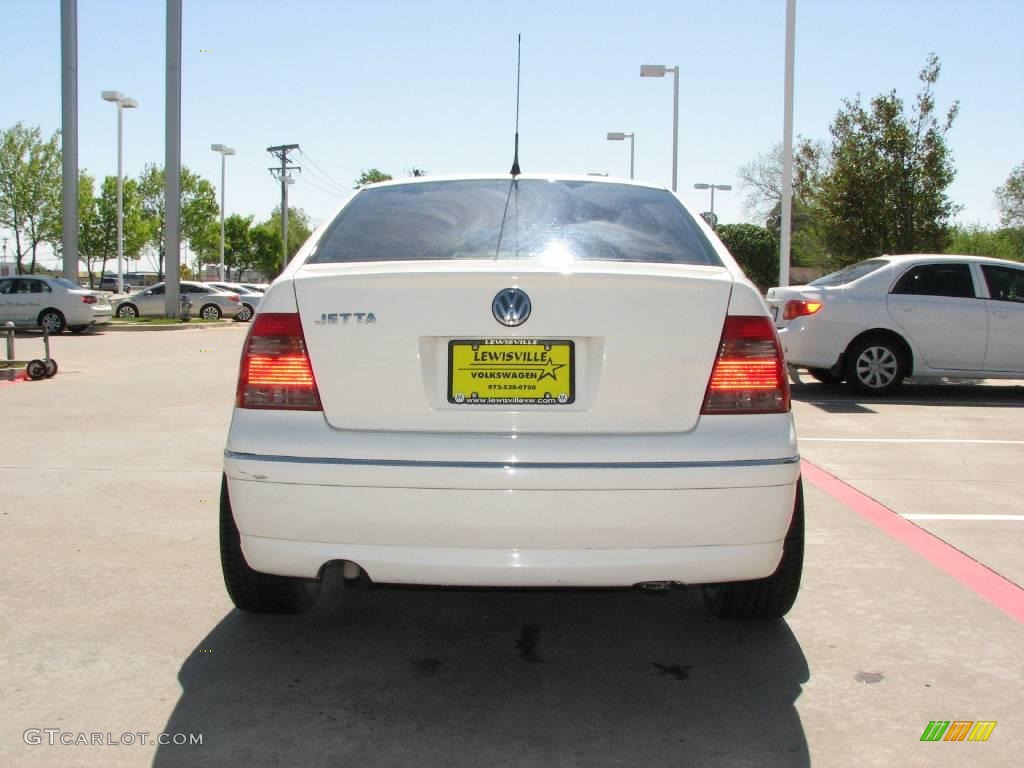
[293,261,732,433]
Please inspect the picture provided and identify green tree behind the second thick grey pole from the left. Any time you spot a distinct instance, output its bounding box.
[138,164,220,278]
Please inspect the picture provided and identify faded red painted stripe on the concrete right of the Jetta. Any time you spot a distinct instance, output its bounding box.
[801,459,1024,624]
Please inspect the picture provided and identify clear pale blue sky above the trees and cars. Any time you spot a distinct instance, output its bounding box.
[0,0,1024,270]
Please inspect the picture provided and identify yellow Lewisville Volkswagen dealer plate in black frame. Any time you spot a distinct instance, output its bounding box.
[447,339,575,406]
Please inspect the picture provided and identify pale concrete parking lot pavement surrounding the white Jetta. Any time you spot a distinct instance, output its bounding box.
[0,325,1024,766]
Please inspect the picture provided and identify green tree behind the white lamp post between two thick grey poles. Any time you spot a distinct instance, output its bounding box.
[78,171,151,288]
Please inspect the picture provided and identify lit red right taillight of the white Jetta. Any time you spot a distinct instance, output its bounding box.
[700,314,790,414]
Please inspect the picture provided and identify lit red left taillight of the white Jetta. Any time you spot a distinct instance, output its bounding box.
[234,312,323,411]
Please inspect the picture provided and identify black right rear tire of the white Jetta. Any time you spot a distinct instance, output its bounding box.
[703,480,804,620]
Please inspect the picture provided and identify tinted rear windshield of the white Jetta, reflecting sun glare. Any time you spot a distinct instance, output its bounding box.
[308,179,722,266]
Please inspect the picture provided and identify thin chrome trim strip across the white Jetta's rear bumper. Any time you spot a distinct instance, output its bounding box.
[224,450,800,469]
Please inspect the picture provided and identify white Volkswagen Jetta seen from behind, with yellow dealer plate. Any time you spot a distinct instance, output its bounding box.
[220,175,804,618]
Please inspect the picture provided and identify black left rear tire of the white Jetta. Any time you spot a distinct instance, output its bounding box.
[220,477,321,613]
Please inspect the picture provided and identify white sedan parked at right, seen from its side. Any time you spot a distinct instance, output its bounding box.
[768,254,1024,395]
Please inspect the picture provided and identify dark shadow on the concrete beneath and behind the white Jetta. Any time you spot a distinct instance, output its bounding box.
[154,578,810,768]
